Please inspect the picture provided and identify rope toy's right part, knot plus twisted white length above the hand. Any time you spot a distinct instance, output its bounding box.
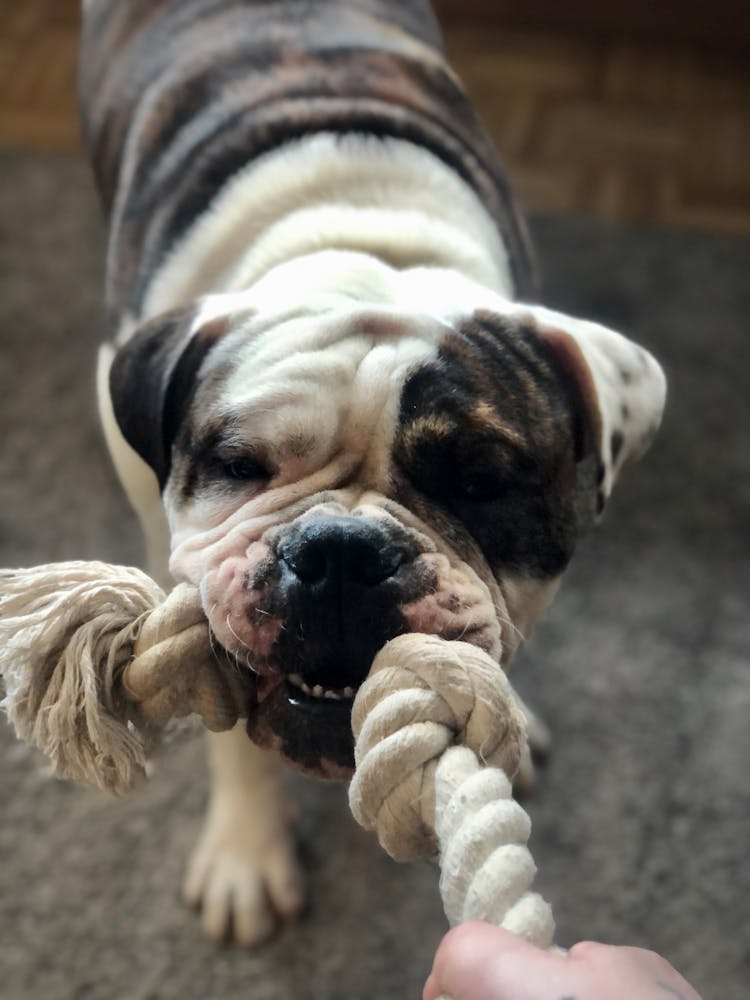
[349,634,554,948]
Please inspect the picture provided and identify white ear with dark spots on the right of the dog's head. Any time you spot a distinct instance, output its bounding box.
[531,307,666,516]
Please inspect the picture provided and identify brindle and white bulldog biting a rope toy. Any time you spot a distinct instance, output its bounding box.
[80,0,665,945]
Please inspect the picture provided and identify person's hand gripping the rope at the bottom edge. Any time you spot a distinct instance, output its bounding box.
[422,923,700,1000]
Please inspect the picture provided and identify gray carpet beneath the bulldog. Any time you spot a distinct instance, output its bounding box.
[0,155,750,1000]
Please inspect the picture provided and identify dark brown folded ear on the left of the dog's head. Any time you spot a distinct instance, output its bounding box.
[109,306,228,489]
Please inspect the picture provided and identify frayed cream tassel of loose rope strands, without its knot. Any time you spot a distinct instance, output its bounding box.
[0,562,165,795]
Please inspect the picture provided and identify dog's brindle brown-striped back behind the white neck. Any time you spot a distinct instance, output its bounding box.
[80,0,531,323]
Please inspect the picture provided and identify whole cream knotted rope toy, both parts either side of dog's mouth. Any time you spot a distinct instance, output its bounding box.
[0,562,554,947]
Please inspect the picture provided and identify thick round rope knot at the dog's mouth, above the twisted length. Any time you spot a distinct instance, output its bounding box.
[349,633,526,861]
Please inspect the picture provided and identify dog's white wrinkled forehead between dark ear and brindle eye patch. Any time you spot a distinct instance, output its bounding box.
[167,309,441,507]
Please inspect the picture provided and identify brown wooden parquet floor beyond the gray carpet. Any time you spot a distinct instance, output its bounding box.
[0,0,750,233]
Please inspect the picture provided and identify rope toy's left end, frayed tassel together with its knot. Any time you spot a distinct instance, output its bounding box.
[0,562,250,795]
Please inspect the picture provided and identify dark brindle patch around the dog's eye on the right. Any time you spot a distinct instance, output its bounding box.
[394,313,576,579]
